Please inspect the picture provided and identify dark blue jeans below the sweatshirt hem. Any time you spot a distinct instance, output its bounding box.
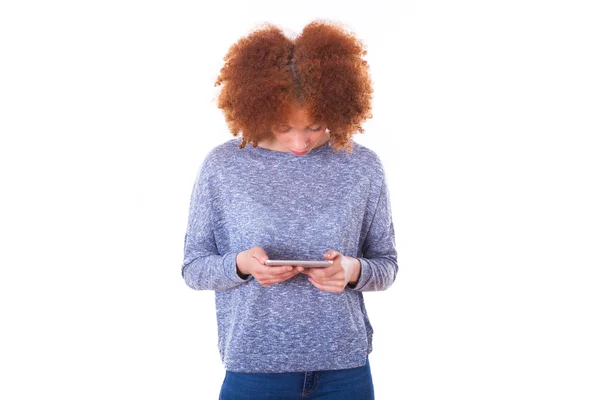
[219,356,375,400]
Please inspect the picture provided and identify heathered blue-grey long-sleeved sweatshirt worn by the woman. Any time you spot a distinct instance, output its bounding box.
[181,138,398,372]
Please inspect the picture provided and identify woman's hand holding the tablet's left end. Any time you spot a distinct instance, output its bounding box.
[235,246,304,286]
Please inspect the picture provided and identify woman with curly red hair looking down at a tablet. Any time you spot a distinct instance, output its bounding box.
[182,21,398,399]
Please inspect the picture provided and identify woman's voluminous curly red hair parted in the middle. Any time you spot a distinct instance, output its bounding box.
[215,20,373,151]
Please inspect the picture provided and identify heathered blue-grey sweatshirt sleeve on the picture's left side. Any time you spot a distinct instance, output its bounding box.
[181,153,253,290]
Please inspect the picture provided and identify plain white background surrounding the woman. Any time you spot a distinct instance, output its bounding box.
[0,0,600,400]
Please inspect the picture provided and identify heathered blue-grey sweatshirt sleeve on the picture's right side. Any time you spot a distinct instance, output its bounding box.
[347,173,398,292]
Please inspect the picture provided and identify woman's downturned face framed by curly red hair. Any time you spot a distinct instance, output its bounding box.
[266,106,329,156]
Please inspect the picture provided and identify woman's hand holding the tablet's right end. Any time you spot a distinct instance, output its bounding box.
[300,250,360,293]
